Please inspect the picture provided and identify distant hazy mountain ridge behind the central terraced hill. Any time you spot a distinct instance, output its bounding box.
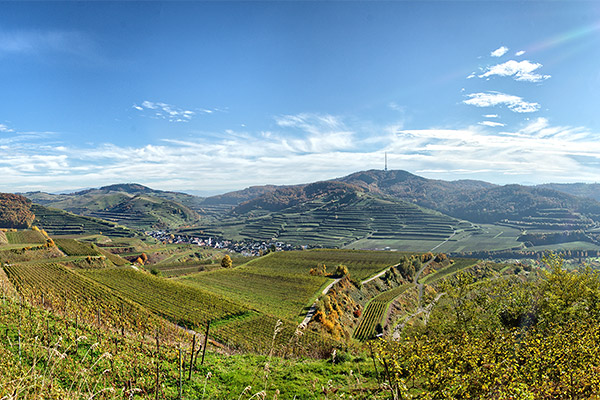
[18,170,600,238]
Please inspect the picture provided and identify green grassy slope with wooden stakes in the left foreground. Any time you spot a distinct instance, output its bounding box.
[0,298,387,400]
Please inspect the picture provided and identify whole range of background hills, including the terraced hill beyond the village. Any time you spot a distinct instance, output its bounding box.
[17,170,600,251]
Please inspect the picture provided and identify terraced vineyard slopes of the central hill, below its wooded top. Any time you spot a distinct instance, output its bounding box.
[208,193,459,248]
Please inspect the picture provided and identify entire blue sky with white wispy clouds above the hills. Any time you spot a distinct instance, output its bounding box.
[0,1,600,195]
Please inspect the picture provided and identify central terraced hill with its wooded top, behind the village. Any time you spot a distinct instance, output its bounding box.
[190,182,477,250]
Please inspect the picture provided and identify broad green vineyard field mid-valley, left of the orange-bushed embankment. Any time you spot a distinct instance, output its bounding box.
[180,250,403,321]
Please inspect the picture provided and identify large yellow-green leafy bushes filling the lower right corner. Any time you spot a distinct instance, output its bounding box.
[374,255,600,399]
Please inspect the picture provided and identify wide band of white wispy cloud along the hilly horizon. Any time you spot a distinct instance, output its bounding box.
[0,112,600,193]
